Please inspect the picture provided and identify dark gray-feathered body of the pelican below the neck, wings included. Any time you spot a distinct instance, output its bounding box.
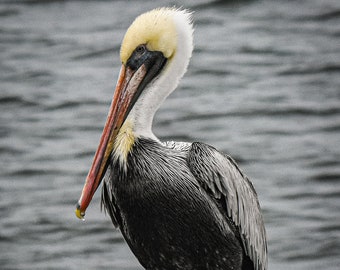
[102,138,267,270]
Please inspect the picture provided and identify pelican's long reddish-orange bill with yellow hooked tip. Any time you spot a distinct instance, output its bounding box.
[75,65,147,219]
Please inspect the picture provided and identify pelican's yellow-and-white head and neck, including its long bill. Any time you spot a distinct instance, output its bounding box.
[76,8,193,218]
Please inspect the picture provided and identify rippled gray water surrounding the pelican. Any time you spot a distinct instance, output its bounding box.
[0,0,340,270]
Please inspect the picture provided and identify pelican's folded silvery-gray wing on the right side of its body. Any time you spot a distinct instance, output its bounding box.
[188,143,267,270]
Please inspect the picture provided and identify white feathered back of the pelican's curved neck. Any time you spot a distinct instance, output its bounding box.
[127,13,193,139]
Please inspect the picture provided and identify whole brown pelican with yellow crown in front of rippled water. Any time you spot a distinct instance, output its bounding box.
[76,8,267,270]
